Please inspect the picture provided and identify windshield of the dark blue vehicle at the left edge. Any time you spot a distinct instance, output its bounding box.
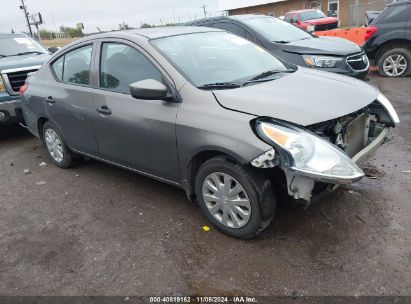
[0,36,47,56]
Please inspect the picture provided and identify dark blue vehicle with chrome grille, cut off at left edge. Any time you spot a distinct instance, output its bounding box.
[0,34,50,127]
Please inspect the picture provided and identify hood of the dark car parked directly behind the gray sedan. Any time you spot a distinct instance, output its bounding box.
[281,37,361,56]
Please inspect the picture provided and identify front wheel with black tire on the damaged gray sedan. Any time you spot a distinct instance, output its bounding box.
[195,156,276,239]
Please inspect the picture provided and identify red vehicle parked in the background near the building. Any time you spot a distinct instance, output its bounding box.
[284,9,340,32]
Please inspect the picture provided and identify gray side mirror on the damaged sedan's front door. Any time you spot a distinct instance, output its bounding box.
[130,79,170,100]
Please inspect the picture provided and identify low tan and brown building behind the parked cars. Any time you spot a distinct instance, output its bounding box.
[221,0,393,27]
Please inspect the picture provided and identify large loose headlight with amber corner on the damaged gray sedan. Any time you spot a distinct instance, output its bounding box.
[256,120,364,184]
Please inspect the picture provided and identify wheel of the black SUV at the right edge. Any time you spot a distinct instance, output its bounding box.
[378,48,411,77]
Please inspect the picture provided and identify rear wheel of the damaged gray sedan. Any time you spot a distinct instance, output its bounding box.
[42,122,78,169]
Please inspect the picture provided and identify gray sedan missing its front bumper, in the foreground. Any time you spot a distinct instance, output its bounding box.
[21,27,399,238]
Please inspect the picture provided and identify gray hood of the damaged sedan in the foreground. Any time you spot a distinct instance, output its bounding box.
[214,67,379,126]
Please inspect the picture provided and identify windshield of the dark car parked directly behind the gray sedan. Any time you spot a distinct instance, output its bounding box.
[243,17,312,43]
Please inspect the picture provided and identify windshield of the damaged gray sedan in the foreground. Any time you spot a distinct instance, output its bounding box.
[152,32,288,87]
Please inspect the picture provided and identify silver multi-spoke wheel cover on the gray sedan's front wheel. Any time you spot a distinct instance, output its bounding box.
[202,172,251,228]
